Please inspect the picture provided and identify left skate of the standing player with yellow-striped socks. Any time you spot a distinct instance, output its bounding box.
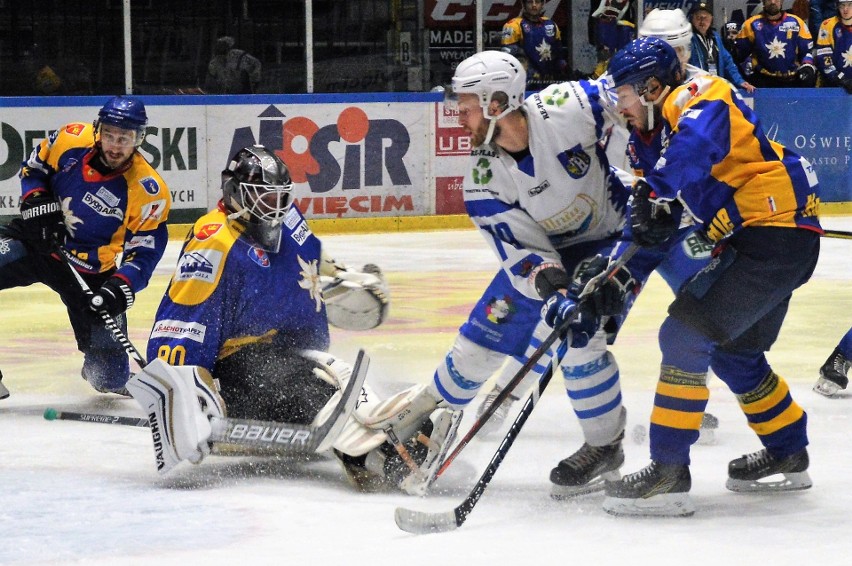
[603,461,695,517]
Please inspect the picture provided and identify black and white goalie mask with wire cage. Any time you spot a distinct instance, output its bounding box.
[222,145,293,253]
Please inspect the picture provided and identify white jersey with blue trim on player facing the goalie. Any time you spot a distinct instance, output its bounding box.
[464,81,629,299]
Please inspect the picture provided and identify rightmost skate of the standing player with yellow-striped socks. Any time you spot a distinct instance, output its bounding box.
[725,448,813,492]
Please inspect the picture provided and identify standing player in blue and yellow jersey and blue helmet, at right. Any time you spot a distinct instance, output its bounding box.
[604,38,822,515]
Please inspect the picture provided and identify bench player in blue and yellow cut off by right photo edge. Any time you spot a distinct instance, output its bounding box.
[816,0,852,94]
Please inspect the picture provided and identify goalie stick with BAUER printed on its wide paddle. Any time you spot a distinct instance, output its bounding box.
[44,350,370,460]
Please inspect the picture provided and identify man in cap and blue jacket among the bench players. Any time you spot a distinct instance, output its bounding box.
[689,0,754,93]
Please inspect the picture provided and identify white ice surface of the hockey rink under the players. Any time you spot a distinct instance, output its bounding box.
[0,217,852,566]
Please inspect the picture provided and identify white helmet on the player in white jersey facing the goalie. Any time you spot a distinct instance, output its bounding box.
[452,51,527,120]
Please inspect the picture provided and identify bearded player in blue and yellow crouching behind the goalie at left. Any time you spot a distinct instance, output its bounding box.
[0,96,171,393]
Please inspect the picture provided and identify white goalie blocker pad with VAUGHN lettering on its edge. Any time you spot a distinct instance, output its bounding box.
[127,359,225,474]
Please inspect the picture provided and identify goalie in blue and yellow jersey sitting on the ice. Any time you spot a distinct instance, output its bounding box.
[138,146,461,492]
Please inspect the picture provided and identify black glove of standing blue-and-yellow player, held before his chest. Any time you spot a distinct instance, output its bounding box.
[630,179,683,248]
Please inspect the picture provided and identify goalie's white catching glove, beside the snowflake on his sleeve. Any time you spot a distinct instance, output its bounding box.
[322,264,390,330]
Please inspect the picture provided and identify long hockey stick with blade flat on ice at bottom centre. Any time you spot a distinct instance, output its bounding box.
[394,243,639,534]
